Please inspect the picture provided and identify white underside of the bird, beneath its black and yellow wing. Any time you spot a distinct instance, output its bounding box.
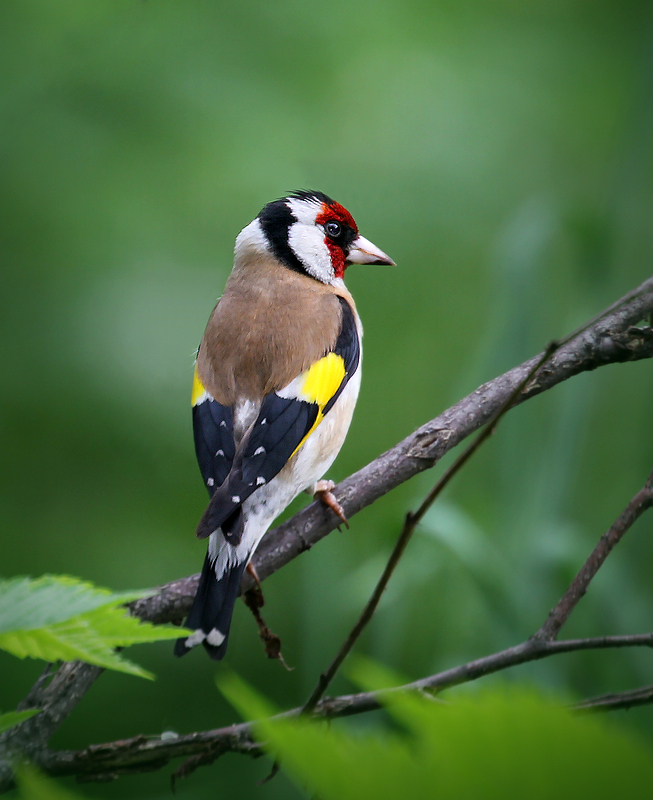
[209,364,362,580]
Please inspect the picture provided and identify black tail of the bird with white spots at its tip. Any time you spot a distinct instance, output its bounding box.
[175,553,247,661]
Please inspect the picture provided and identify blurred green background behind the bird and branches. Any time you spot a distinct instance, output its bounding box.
[0,0,653,798]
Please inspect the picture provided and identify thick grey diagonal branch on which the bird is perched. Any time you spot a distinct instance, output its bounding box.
[0,278,653,791]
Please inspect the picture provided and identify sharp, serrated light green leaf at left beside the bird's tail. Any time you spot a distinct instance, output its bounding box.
[0,575,186,678]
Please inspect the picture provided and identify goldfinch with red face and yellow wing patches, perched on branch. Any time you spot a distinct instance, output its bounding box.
[175,190,395,660]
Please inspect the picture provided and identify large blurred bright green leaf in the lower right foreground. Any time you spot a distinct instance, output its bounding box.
[218,667,653,800]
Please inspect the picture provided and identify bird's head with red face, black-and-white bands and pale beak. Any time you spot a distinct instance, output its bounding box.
[235,190,394,283]
